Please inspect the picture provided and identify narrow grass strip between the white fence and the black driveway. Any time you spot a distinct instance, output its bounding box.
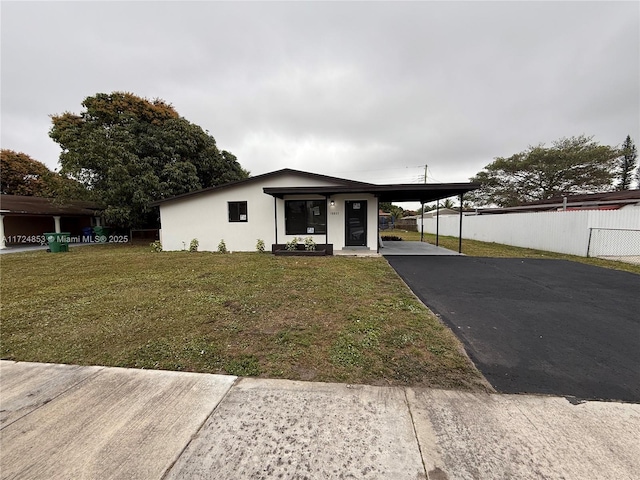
[382,230,640,274]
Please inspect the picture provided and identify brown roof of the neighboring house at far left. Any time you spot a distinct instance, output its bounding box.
[0,195,102,216]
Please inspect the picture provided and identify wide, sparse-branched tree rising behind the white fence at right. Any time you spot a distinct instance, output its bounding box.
[467,135,619,207]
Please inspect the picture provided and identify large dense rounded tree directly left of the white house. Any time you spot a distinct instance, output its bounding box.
[49,92,248,227]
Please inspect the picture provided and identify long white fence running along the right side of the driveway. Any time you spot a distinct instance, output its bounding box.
[417,207,640,257]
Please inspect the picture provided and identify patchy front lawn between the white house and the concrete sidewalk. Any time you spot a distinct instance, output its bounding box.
[0,245,486,390]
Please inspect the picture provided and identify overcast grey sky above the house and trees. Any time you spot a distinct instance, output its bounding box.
[0,1,640,191]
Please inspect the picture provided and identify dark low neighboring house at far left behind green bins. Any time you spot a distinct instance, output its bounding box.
[0,195,101,248]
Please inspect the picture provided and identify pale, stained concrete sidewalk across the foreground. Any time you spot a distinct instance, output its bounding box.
[0,361,640,480]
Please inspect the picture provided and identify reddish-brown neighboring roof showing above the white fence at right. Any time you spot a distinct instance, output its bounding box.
[477,189,640,215]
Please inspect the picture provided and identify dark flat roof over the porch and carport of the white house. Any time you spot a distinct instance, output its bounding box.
[263,183,480,203]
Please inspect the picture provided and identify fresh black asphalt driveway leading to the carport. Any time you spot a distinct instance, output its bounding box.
[387,256,640,402]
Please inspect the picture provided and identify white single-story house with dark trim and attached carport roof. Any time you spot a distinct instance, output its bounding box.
[151,169,478,251]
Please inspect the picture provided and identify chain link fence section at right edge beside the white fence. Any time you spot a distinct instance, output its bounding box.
[587,228,640,265]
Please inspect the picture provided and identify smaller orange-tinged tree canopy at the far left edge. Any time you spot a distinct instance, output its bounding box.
[0,149,87,200]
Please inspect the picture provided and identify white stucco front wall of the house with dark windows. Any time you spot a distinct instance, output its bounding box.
[160,174,378,251]
